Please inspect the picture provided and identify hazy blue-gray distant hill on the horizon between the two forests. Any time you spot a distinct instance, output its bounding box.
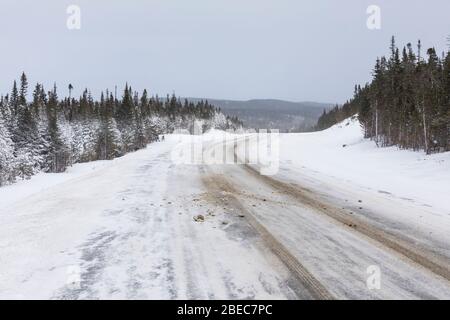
[187,98,333,132]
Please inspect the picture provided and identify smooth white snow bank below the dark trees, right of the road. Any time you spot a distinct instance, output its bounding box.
[280,118,450,212]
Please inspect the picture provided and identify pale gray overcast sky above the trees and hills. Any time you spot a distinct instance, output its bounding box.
[0,0,450,102]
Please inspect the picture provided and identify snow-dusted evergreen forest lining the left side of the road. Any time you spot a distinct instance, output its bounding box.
[0,73,242,186]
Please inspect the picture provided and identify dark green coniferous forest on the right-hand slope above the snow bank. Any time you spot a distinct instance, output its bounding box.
[317,37,450,153]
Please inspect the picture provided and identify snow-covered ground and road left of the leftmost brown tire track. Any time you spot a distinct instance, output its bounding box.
[0,139,309,299]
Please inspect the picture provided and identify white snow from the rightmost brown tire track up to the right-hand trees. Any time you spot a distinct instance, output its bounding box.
[270,118,450,261]
